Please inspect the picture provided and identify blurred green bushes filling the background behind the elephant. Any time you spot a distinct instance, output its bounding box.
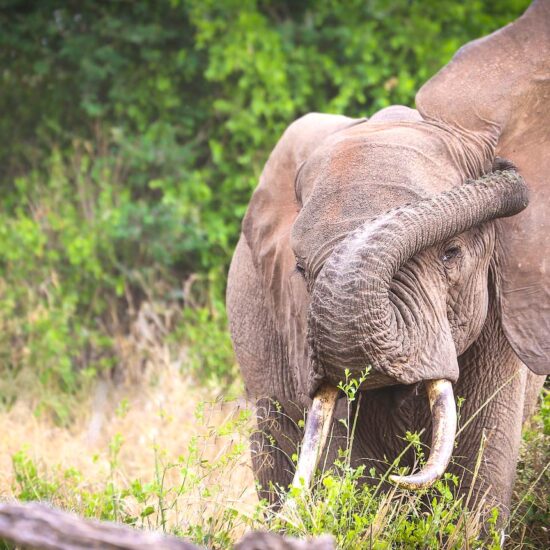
[0,0,528,421]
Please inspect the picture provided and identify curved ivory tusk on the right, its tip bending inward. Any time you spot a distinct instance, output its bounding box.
[390,380,456,491]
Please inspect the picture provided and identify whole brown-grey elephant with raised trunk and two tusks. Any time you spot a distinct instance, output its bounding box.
[227,0,550,528]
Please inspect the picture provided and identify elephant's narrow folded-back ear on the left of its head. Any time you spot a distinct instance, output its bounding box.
[243,113,365,405]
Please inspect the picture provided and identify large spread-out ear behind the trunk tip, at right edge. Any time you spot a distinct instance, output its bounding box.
[416,0,550,374]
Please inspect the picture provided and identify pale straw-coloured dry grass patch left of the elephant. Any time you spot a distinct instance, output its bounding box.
[0,369,257,535]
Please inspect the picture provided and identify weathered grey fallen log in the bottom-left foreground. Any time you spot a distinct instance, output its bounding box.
[0,502,334,550]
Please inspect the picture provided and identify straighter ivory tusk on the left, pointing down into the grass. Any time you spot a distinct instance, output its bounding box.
[292,384,338,489]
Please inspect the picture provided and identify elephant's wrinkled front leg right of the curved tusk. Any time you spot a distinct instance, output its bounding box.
[452,300,527,523]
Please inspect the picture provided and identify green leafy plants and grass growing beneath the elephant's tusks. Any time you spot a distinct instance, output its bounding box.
[274,369,512,550]
